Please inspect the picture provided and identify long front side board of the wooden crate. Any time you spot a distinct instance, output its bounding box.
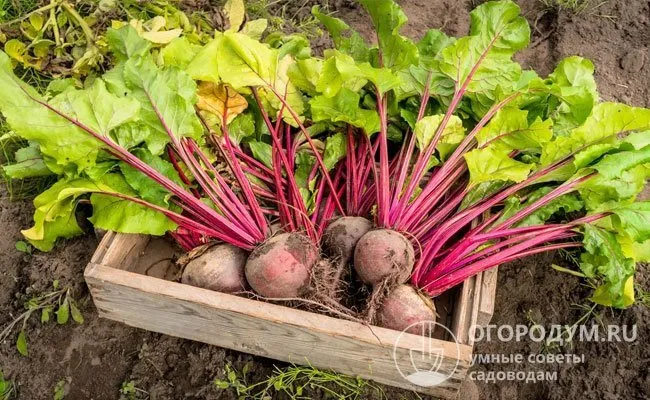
[85,263,472,398]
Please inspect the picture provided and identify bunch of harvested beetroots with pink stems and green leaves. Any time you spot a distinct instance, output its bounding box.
[5,0,650,338]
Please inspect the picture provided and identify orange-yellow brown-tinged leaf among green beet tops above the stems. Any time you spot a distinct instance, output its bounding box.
[196,82,248,124]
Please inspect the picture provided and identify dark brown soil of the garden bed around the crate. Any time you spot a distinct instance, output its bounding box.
[0,0,650,400]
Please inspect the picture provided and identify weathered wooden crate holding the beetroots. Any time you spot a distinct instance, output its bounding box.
[85,232,496,398]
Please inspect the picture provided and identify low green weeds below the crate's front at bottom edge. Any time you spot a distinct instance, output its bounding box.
[214,363,385,400]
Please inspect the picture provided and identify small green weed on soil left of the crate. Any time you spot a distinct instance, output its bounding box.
[0,280,84,356]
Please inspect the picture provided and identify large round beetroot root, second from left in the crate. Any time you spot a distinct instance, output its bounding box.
[245,232,319,299]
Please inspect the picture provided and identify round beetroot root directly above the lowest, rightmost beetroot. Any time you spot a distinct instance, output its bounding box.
[354,229,415,286]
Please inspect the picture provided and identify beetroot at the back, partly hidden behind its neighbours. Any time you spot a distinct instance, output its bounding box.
[323,217,372,264]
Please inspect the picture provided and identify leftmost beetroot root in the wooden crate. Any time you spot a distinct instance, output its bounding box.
[181,244,248,293]
